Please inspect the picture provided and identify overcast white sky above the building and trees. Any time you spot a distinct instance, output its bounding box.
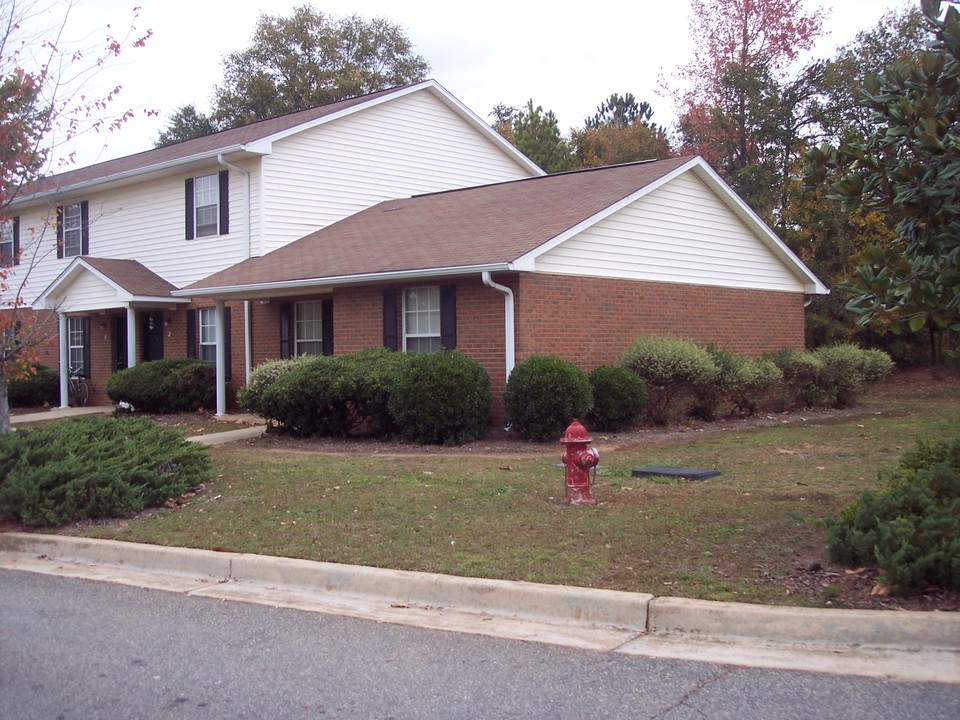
[31,0,917,166]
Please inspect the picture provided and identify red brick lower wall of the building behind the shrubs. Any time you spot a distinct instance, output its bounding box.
[11,273,804,422]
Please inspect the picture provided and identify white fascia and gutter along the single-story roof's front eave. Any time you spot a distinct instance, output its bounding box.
[172,263,516,299]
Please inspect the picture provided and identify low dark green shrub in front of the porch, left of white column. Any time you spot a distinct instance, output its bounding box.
[107,358,216,413]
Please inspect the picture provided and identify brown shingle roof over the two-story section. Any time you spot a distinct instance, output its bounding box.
[20,83,419,199]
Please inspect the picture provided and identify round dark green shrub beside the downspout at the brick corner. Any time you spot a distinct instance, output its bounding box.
[503,355,593,440]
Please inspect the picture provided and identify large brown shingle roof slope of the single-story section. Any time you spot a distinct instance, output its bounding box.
[184,158,690,294]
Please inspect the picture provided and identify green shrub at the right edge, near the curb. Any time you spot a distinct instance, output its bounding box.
[826,438,960,593]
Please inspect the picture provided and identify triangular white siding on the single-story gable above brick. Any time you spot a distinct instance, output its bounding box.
[535,173,804,292]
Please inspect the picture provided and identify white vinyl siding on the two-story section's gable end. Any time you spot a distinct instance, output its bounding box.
[262,92,532,252]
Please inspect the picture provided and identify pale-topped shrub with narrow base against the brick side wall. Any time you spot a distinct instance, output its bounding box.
[619,335,720,425]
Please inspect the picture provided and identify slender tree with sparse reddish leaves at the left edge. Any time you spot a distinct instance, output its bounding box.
[0,0,151,434]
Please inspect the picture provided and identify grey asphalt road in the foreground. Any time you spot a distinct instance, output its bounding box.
[0,570,960,720]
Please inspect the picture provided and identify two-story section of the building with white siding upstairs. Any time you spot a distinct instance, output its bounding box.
[0,81,542,405]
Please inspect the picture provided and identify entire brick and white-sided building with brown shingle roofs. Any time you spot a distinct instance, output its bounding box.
[0,81,827,422]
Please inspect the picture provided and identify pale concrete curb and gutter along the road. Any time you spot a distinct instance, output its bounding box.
[0,533,960,683]
